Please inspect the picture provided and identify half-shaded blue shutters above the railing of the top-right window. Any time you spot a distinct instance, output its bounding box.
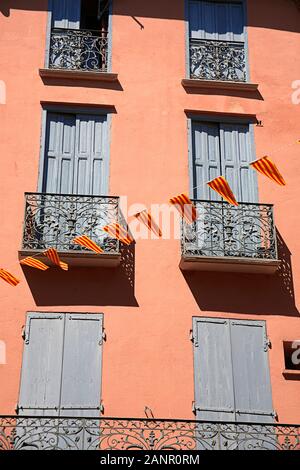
[189,0,245,42]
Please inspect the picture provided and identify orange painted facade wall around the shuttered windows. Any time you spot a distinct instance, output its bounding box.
[0,0,300,423]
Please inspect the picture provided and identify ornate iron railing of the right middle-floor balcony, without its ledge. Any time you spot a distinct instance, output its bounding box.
[181,200,278,260]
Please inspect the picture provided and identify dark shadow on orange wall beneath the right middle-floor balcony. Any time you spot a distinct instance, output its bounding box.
[182,232,299,316]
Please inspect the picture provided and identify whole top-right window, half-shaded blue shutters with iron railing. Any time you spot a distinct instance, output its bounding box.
[189,0,247,82]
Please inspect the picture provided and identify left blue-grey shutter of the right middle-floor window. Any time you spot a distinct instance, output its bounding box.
[192,121,221,201]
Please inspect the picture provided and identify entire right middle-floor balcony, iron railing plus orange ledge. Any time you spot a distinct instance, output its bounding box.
[181,200,279,273]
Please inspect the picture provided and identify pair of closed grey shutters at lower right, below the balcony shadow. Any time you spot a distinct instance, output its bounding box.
[194,318,274,423]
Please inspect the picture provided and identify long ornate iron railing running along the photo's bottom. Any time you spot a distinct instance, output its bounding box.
[0,416,300,451]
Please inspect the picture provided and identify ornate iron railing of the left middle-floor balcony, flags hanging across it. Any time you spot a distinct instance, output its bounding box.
[22,193,123,254]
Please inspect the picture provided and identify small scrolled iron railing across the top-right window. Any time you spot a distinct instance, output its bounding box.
[190,39,246,82]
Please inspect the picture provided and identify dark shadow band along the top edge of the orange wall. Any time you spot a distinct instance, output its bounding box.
[0,0,300,31]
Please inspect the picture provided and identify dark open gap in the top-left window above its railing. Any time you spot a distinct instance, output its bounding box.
[80,0,109,33]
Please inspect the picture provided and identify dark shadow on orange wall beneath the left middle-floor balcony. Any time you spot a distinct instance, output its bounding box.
[22,244,138,307]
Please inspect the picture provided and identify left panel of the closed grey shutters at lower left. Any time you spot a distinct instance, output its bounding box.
[19,313,64,416]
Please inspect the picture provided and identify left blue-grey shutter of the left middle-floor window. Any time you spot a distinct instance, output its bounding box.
[42,113,76,194]
